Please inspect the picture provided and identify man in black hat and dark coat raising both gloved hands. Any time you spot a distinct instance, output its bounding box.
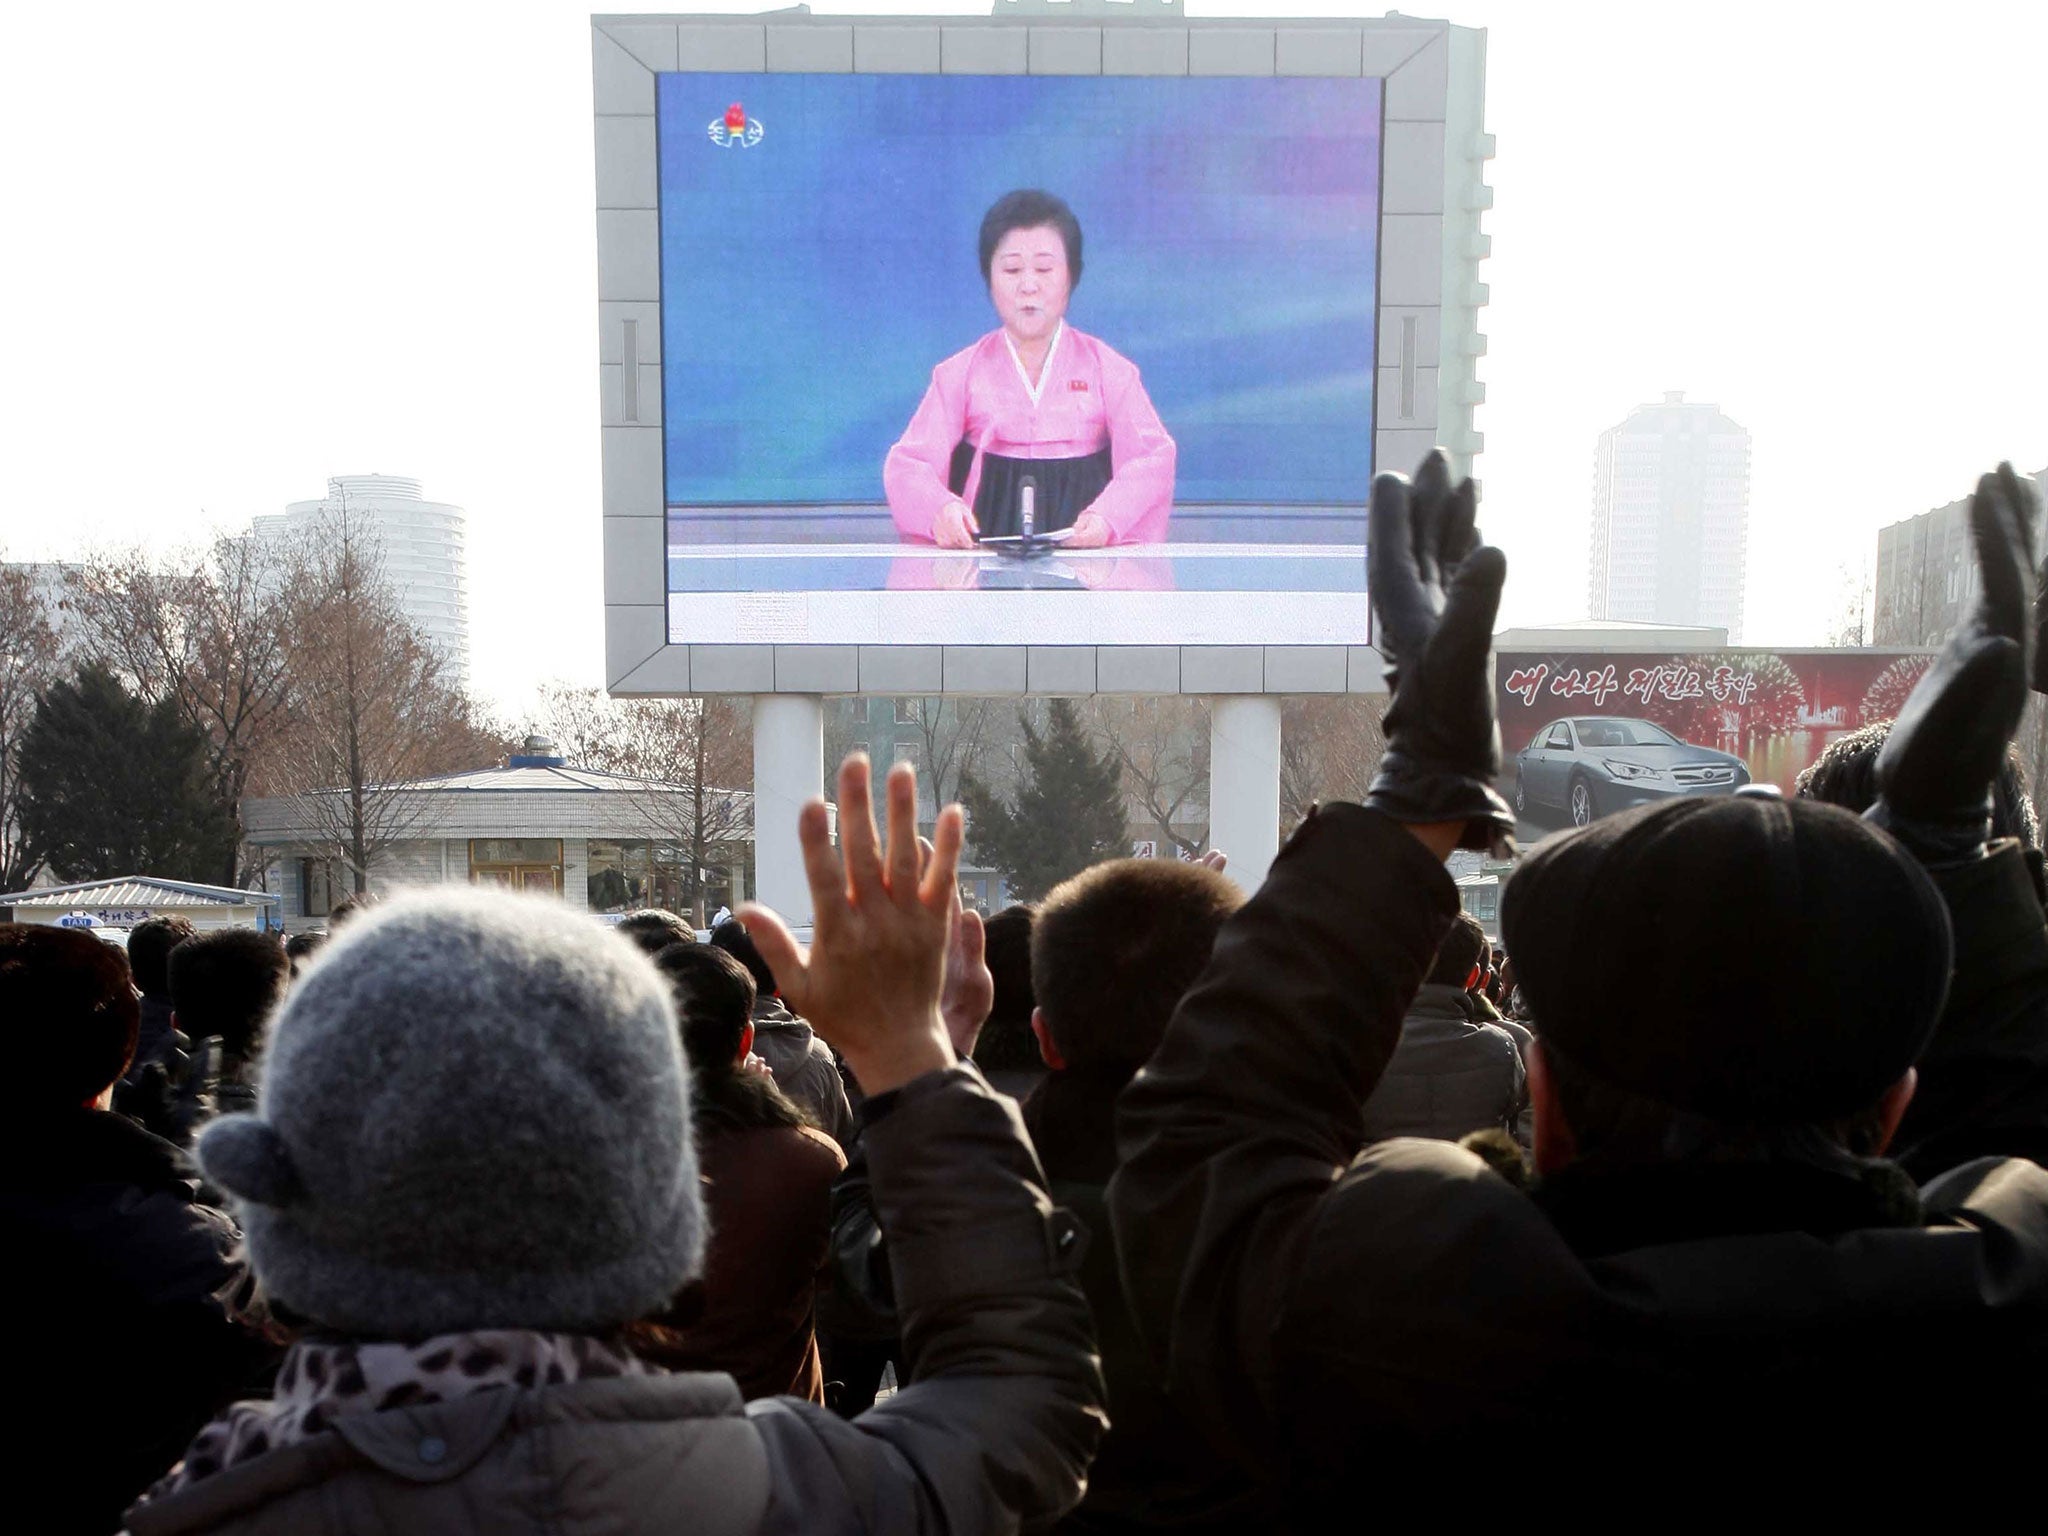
[1108,453,2048,1528]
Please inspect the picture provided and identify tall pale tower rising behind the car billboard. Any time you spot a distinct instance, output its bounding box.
[1589,389,1749,641]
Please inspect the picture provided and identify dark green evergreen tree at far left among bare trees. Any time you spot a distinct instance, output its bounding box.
[20,662,236,881]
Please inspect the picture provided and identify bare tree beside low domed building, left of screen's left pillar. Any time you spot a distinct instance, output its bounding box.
[537,682,754,928]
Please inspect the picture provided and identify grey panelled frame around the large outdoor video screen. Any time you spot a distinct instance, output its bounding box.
[592,16,1491,694]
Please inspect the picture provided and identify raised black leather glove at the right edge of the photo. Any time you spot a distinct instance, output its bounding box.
[1864,465,2040,864]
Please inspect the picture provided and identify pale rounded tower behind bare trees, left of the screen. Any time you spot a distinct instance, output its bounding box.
[250,475,469,682]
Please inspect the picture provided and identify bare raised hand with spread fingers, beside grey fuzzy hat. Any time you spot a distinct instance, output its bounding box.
[741,754,961,1096]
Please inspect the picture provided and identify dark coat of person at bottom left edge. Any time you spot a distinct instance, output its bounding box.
[0,1108,274,1532]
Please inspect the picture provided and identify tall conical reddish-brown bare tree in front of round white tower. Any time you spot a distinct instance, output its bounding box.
[264,504,500,893]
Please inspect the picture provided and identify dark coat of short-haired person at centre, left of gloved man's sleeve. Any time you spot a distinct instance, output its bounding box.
[1024,1069,1262,1534]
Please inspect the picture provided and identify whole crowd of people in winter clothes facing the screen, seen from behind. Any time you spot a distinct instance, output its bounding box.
[12,455,2048,1536]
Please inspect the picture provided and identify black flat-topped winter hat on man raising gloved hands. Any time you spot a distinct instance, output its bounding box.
[1501,795,1952,1124]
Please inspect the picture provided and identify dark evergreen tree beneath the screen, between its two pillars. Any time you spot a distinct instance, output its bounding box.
[961,698,1130,901]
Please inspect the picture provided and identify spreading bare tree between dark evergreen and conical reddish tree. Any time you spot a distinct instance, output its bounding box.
[66,535,305,885]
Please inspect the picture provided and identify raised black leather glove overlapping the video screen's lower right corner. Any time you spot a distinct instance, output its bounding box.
[1366,449,1516,854]
